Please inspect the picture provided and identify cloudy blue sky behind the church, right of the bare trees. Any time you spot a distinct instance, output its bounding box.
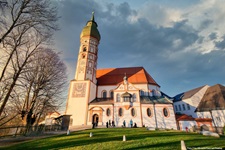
[54,0,225,96]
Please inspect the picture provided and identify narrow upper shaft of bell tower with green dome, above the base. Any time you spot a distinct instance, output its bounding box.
[75,12,100,84]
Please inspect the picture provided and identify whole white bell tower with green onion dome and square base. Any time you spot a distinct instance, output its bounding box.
[66,13,101,126]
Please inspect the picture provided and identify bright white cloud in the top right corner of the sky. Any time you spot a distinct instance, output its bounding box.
[183,0,225,54]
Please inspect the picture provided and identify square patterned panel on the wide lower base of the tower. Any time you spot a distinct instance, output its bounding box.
[72,83,86,98]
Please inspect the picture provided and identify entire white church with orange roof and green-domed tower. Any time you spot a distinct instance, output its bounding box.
[66,14,177,129]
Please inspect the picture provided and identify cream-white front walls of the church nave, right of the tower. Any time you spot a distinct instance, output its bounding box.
[88,83,177,129]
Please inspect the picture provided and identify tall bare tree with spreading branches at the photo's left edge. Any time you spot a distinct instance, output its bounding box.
[0,0,58,117]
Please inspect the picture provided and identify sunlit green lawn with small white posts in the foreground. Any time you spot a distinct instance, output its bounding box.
[0,128,225,150]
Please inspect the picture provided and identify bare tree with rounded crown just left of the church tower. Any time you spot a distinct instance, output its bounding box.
[0,48,67,131]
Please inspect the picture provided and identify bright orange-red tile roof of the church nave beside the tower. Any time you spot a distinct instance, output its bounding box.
[96,67,159,86]
